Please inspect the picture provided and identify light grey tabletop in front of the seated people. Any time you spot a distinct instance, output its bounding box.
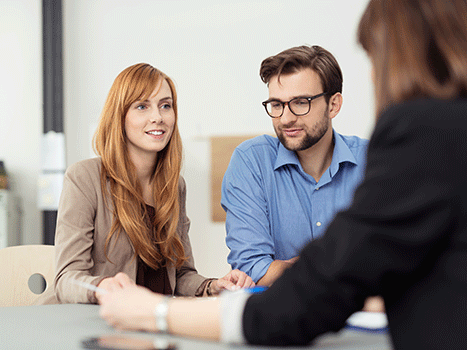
[0,304,392,350]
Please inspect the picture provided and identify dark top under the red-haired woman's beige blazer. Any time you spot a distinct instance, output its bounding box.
[136,205,172,295]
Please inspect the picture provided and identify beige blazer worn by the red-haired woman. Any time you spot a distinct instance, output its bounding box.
[37,158,206,304]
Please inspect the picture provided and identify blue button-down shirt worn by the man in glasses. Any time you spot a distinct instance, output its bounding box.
[221,131,368,282]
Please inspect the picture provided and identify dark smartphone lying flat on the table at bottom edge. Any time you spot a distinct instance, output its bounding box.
[81,334,177,350]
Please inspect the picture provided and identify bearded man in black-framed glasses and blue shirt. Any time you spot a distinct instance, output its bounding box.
[221,46,368,286]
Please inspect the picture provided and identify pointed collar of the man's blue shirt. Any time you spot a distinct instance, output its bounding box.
[274,129,357,176]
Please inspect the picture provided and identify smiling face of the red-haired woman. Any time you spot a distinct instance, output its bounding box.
[125,79,175,164]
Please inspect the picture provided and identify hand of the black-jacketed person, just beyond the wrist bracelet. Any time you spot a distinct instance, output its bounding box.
[99,284,162,332]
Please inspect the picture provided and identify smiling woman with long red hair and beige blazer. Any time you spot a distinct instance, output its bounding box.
[41,63,254,303]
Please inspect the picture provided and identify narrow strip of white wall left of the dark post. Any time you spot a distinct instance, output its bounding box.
[0,0,43,244]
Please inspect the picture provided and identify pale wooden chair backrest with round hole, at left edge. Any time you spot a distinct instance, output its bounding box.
[0,245,55,306]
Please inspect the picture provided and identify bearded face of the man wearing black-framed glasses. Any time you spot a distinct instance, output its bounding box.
[269,68,331,151]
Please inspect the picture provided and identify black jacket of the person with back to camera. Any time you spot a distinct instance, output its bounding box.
[243,99,467,349]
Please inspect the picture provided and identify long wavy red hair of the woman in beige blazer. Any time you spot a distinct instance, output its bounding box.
[93,63,186,269]
